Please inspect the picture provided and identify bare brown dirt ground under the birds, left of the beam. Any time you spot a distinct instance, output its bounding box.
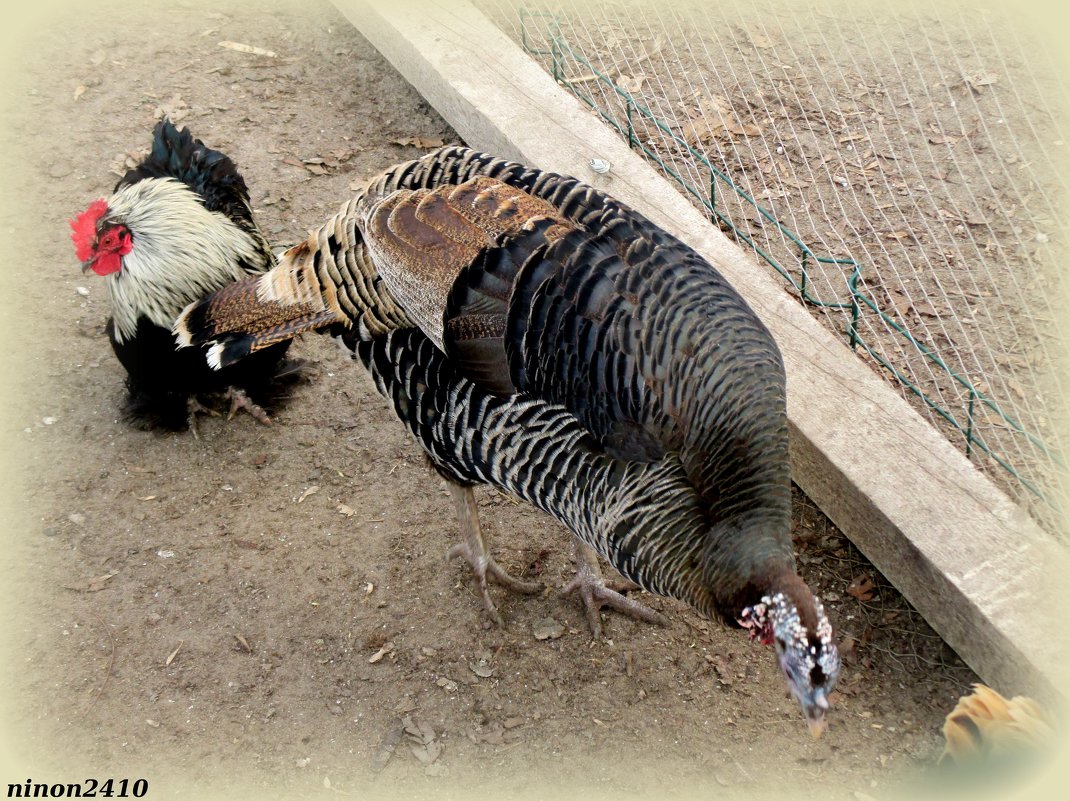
[0,0,1052,799]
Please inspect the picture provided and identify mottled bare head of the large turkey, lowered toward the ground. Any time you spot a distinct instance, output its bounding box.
[739,592,840,737]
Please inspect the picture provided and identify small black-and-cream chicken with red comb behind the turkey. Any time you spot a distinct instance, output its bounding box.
[71,119,297,434]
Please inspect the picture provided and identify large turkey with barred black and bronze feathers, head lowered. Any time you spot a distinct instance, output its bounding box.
[175,147,840,736]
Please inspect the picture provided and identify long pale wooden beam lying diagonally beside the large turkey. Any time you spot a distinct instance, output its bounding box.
[335,0,1068,697]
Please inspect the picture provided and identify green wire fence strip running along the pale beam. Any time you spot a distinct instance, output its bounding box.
[518,7,1067,512]
